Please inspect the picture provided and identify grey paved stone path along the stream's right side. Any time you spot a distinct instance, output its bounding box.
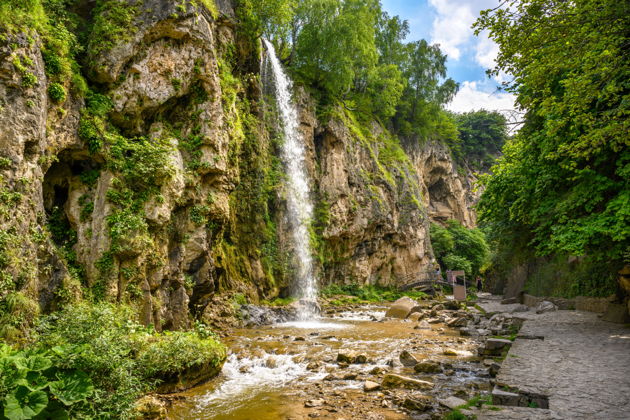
[478,301,630,420]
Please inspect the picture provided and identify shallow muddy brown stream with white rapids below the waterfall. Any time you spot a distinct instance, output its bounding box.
[168,306,489,420]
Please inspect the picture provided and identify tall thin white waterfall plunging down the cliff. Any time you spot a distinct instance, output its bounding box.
[262,39,319,321]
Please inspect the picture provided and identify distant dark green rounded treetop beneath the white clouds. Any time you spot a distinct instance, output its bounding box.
[455,109,507,171]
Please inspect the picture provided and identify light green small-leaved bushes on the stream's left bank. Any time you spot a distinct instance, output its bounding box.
[34,303,226,419]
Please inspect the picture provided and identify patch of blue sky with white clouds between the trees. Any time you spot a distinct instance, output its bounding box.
[381,0,514,112]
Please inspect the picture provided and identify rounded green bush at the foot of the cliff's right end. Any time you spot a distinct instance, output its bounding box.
[430,220,490,277]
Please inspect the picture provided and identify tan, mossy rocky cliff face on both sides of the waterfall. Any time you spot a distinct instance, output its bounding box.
[0,0,474,329]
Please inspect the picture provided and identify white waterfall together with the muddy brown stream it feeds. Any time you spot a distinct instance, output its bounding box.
[168,41,492,420]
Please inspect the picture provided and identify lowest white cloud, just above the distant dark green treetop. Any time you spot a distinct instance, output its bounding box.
[446,82,515,112]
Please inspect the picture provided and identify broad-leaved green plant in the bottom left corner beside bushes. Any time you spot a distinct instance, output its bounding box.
[0,343,94,420]
